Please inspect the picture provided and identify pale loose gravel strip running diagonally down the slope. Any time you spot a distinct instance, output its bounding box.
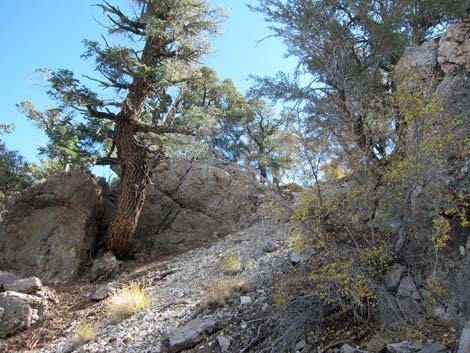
[35,219,290,353]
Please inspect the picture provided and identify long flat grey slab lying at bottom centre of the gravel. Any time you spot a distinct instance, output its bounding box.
[168,317,219,353]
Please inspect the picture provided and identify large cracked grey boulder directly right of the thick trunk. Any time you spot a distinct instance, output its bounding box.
[135,158,259,253]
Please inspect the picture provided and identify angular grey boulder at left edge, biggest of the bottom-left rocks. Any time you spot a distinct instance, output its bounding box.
[0,292,47,338]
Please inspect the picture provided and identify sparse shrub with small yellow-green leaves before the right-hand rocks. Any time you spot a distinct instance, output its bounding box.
[284,69,468,320]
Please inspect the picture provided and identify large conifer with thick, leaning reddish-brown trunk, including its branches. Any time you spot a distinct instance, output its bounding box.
[21,0,226,257]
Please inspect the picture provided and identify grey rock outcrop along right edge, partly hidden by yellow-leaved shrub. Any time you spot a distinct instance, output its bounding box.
[392,19,470,326]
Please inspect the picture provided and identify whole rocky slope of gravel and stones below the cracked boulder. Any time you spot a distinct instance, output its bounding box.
[30,214,292,353]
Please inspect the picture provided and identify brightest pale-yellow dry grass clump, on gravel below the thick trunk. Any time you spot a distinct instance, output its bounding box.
[106,283,151,322]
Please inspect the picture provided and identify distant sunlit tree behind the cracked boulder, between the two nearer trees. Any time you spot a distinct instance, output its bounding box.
[181,67,293,180]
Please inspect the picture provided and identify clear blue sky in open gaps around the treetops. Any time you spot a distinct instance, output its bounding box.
[0,0,295,168]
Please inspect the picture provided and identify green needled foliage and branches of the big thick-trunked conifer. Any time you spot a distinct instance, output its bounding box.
[19,0,227,170]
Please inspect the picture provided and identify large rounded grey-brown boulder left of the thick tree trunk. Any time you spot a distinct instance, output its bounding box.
[0,173,103,283]
